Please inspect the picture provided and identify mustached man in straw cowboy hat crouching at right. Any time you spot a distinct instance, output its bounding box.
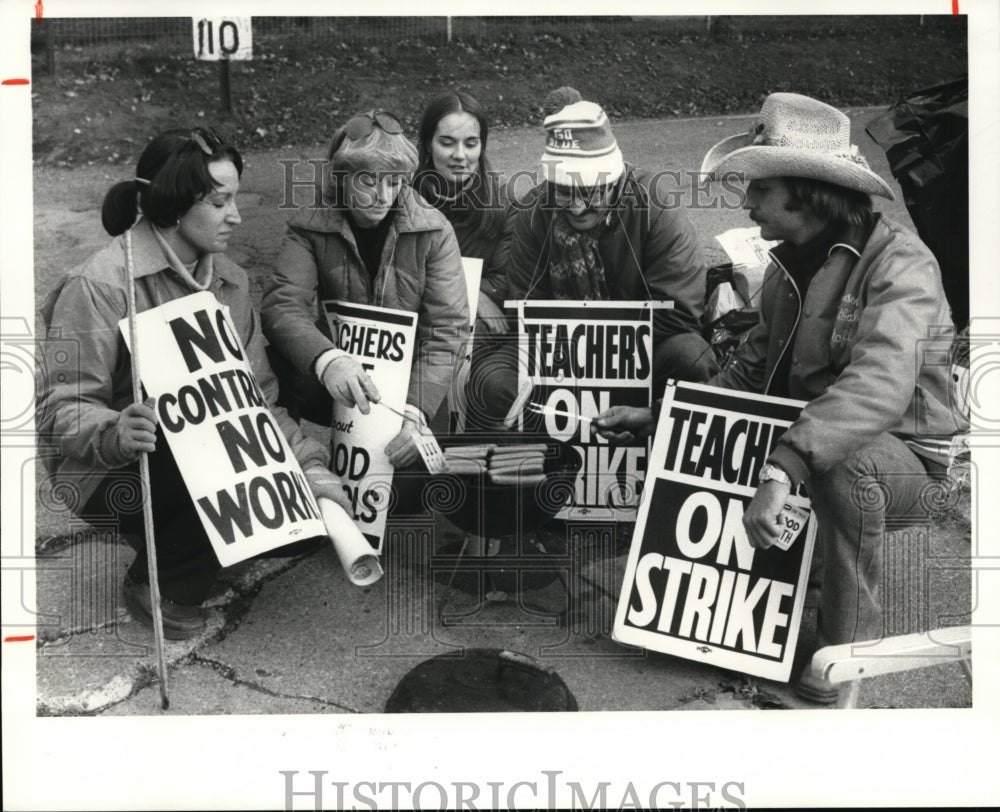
[597,93,967,703]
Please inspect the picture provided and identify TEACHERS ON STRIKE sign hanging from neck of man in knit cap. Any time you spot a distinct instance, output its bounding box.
[507,300,672,521]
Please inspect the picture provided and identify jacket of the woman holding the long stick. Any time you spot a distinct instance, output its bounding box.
[36,220,327,507]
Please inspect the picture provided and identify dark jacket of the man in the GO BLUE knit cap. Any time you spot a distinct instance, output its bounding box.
[504,166,705,341]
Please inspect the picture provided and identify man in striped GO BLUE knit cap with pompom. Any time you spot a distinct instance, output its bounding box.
[467,97,718,426]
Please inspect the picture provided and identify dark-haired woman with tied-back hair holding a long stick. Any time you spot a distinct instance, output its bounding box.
[37,128,348,640]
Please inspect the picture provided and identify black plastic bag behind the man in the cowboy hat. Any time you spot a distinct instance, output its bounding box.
[866,76,969,330]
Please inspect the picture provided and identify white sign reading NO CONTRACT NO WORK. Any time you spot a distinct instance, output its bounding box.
[119,291,325,567]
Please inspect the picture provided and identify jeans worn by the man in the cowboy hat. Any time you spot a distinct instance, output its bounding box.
[806,433,941,647]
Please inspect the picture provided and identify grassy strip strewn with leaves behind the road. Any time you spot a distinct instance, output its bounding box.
[33,15,967,166]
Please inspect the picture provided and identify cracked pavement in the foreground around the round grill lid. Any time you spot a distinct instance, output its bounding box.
[36,504,971,716]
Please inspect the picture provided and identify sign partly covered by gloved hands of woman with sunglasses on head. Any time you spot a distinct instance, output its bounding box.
[323,301,417,552]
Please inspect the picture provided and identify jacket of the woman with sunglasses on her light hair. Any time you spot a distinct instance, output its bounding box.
[261,186,469,418]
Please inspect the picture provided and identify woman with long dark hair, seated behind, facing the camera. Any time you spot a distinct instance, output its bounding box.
[414,90,508,334]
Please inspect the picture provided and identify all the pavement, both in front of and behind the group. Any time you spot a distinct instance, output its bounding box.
[27,116,974,716]
